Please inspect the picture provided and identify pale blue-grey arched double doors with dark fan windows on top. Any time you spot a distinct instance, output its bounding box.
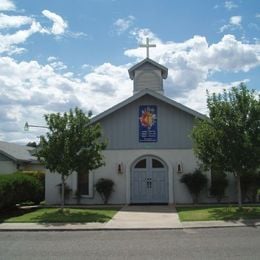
[131,156,169,204]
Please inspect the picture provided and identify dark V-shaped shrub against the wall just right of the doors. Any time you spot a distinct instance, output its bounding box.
[180,169,208,203]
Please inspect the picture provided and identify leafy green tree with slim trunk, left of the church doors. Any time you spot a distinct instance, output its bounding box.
[37,108,106,209]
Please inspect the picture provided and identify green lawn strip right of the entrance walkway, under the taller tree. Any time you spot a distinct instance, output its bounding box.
[177,206,260,221]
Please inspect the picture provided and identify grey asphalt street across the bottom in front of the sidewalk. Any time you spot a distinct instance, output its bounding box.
[0,227,260,260]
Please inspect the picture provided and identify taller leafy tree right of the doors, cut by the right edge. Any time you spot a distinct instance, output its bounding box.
[192,84,260,207]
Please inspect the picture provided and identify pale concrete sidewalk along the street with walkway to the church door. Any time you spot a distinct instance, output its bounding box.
[0,206,260,231]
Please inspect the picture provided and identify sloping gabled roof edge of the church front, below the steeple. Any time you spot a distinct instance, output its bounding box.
[91,88,206,123]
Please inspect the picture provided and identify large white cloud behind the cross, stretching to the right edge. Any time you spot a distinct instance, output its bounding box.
[125,29,260,98]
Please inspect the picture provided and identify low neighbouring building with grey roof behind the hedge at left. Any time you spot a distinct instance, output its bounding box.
[0,141,43,174]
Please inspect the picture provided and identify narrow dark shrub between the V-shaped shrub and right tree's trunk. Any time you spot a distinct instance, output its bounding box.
[210,173,228,202]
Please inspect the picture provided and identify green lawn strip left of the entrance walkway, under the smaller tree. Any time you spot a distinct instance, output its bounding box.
[0,208,119,223]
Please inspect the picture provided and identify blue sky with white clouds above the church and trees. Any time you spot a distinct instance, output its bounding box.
[0,0,260,144]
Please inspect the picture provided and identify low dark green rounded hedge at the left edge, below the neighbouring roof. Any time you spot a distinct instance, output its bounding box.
[0,173,44,209]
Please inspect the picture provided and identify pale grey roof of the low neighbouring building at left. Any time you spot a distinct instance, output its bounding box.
[0,141,37,162]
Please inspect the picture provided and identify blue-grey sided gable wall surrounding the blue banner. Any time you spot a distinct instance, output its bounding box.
[100,95,194,150]
